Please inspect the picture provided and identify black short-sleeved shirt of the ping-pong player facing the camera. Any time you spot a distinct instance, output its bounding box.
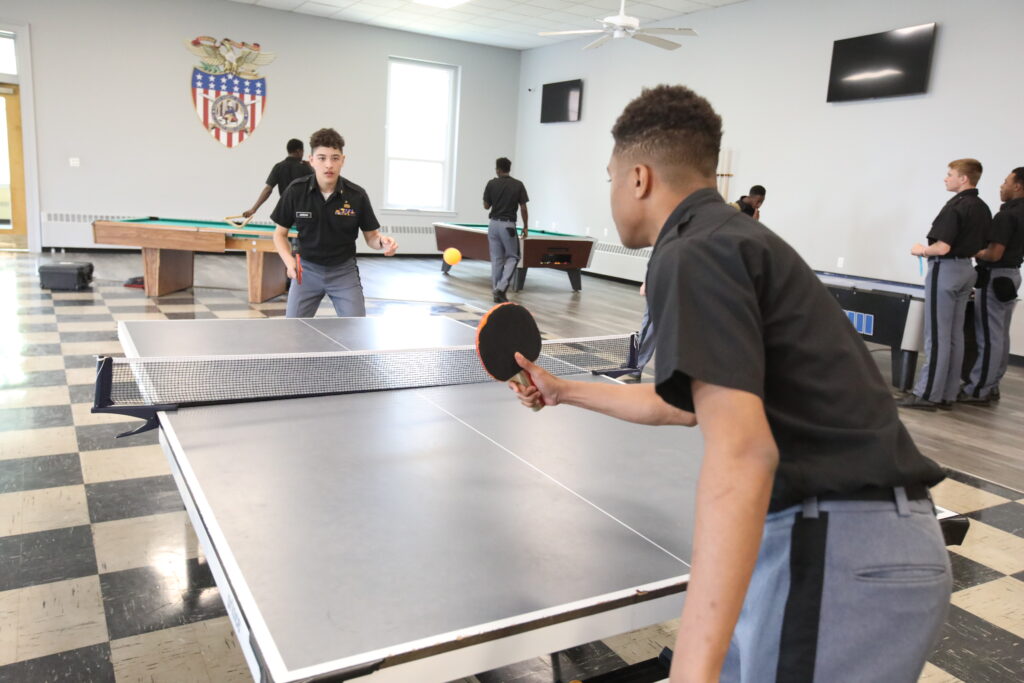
[270,175,381,266]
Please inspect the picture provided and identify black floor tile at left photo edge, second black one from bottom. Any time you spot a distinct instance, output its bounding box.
[0,524,97,591]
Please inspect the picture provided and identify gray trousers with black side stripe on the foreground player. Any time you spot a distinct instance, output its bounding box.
[719,487,952,683]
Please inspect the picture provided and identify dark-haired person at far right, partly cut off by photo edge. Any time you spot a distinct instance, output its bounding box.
[956,166,1024,404]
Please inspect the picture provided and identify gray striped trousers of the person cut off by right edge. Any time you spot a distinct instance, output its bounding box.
[964,268,1021,398]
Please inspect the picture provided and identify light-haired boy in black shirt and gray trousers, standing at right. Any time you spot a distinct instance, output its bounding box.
[897,159,992,411]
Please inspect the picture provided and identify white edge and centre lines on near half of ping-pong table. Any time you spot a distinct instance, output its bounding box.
[159,391,690,681]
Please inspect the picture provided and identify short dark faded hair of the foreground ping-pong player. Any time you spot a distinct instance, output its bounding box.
[611,85,722,177]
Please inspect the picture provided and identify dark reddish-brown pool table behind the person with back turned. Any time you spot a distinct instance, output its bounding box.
[434,223,597,292]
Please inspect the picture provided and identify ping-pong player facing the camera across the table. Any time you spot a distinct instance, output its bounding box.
[270,128,398,317]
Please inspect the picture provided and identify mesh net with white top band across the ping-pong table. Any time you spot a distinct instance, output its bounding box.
[93,336,632,428]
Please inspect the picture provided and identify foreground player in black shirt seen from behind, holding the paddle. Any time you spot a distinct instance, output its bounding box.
[512,86,951,682]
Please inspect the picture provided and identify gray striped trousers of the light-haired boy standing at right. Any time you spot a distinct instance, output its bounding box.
[913,256,978,402]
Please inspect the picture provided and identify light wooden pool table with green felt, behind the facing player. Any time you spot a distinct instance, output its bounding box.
[92,216,298,303]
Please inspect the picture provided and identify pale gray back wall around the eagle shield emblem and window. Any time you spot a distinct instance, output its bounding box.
[0,0,519,247]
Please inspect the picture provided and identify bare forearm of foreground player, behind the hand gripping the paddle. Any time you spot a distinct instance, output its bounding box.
[558,380,696,427]
